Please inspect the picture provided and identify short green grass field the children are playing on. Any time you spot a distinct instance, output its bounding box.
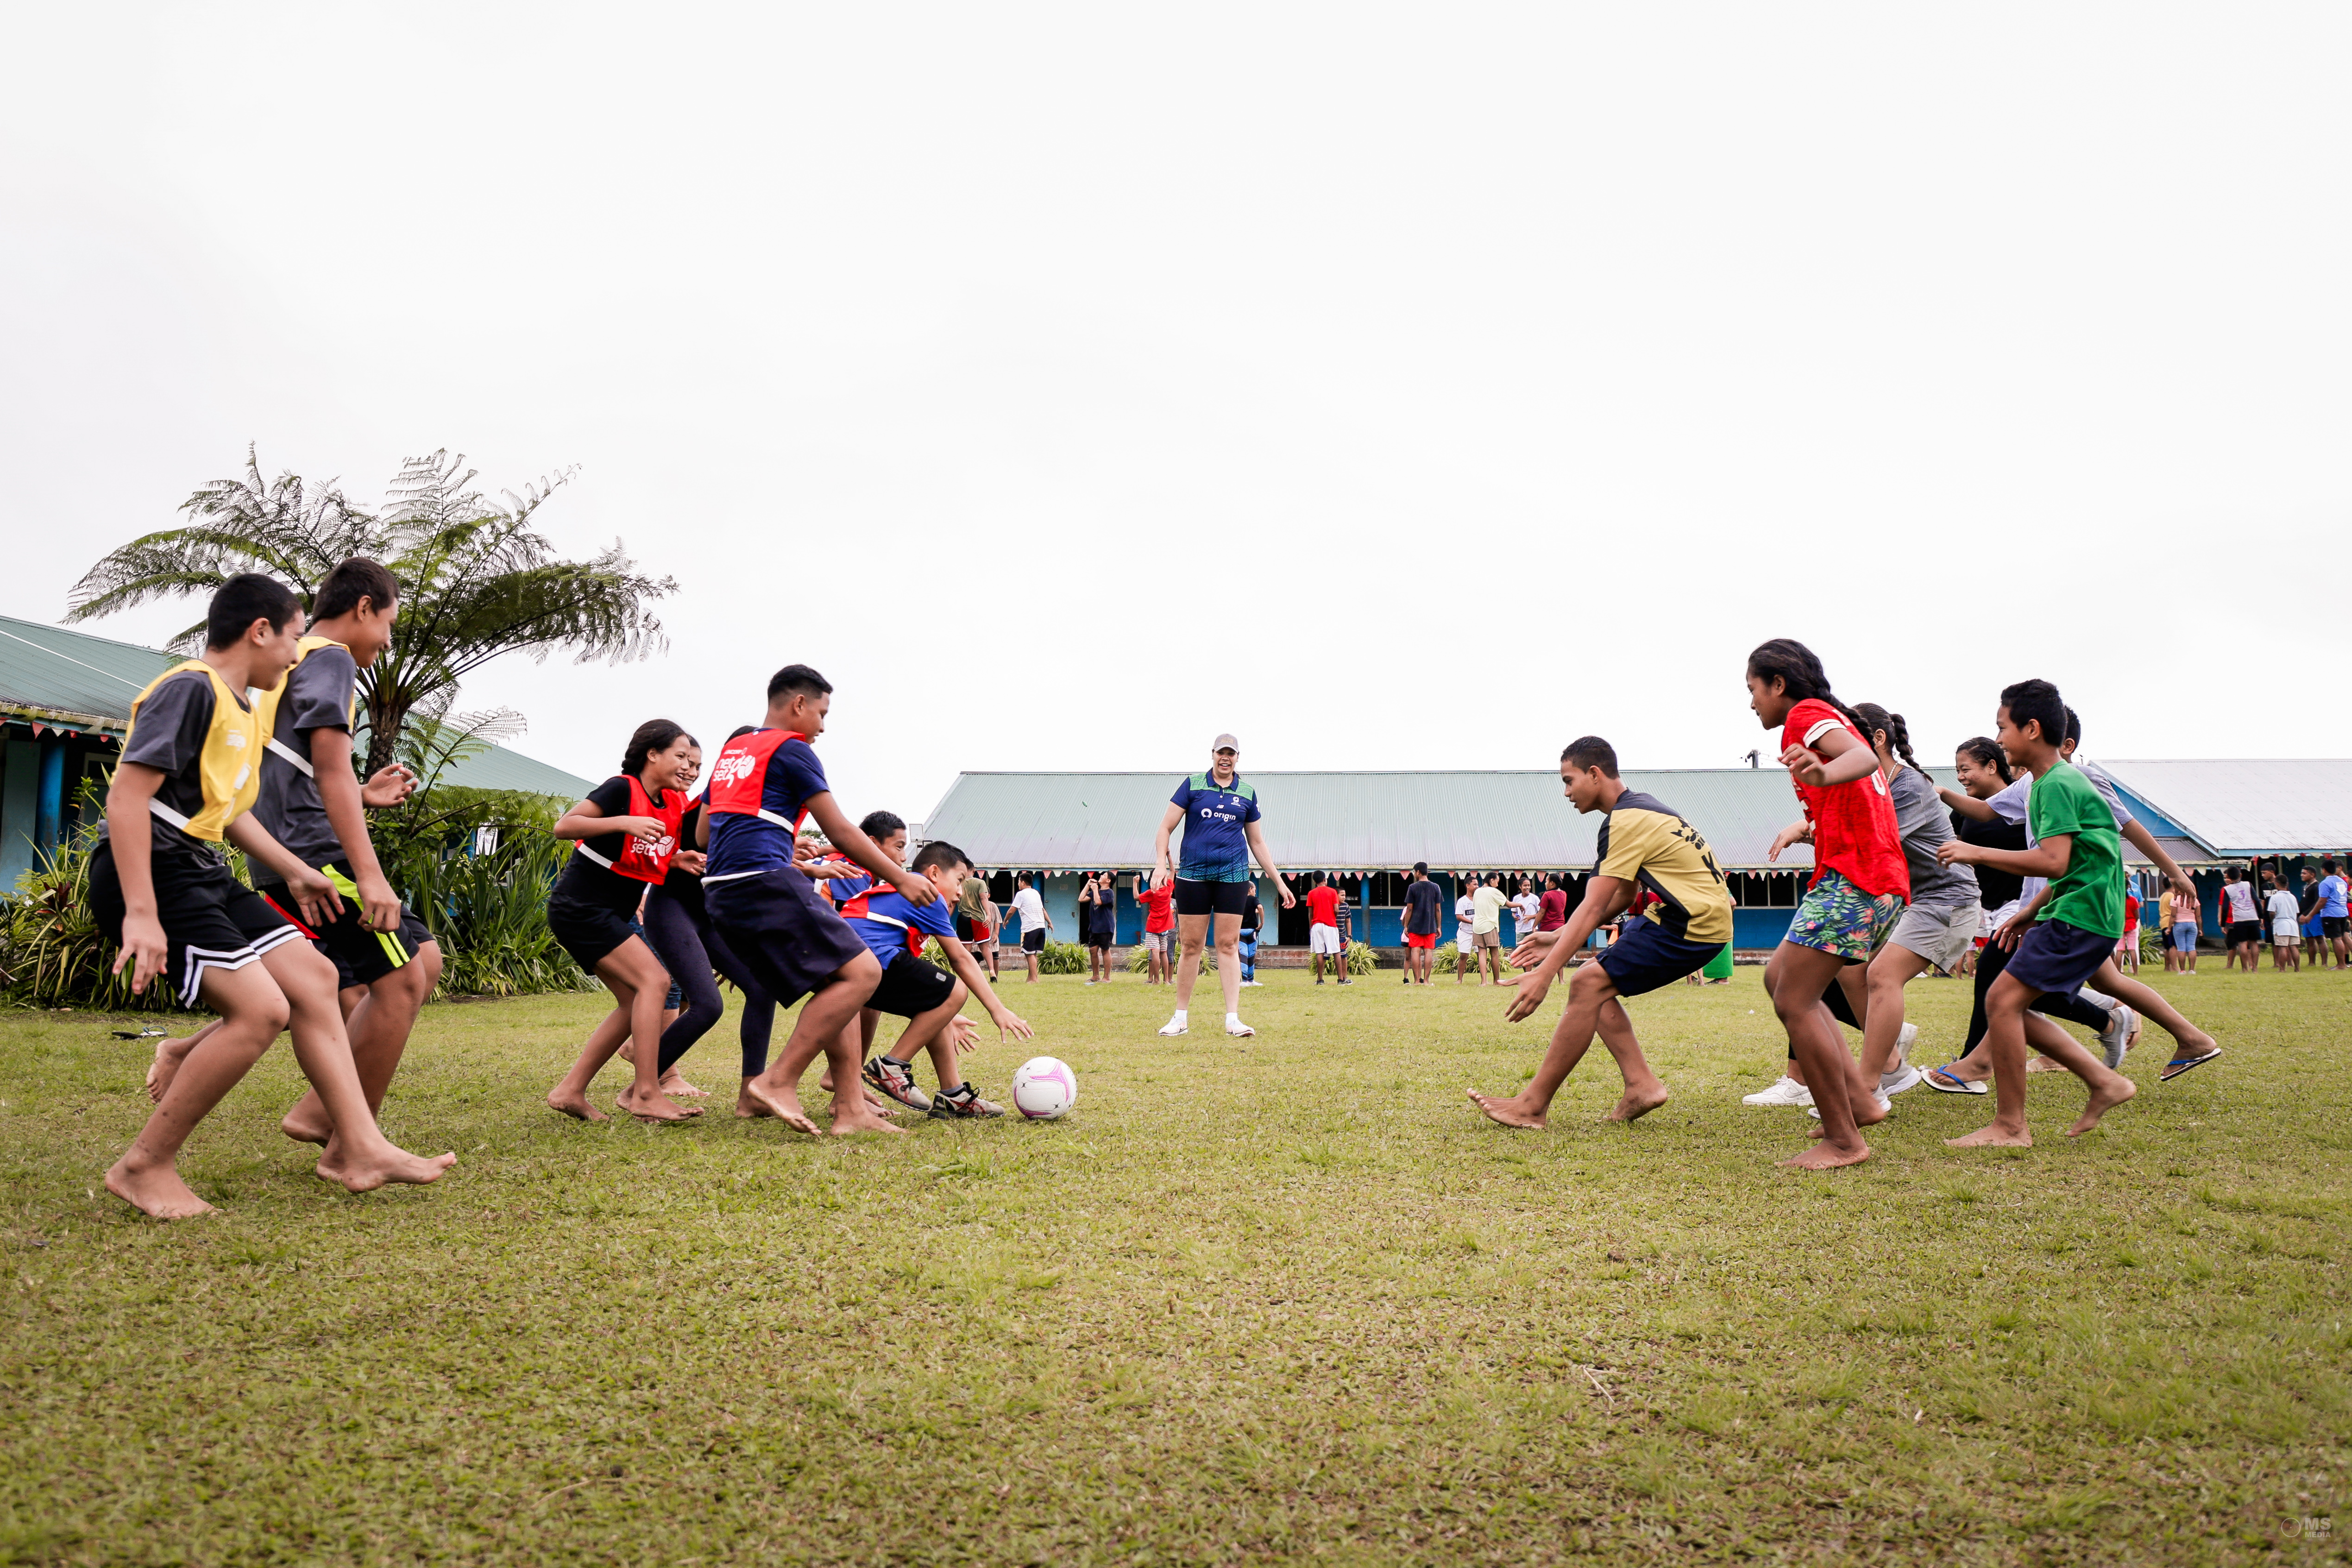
[0,969,2352,1563]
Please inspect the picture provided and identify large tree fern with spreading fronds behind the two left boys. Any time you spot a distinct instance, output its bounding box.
[66,447,677,774]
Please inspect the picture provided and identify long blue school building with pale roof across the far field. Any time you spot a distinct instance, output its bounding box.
[917,762,2352,952]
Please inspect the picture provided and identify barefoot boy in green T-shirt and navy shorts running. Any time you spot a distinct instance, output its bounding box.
[1938,680,2138,1150]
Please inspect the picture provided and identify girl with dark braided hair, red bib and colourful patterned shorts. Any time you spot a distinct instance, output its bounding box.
[1748,637,1910,1171]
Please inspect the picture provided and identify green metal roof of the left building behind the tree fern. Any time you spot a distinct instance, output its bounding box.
[0,616,595,799]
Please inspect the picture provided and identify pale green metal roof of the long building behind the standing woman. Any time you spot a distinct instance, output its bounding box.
[924,769,1891,870]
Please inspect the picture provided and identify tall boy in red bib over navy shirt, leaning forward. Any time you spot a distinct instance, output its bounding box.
[703,665,953,1138]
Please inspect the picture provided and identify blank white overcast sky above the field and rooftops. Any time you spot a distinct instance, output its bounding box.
[0,2,2352,823]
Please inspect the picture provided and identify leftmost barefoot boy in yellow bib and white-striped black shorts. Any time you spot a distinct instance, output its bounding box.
[89,573,454,1220]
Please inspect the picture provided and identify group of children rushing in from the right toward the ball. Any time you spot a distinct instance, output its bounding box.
[1470,639,2220,1171]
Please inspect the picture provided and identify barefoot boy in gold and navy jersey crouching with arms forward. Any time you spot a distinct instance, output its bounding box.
[1470,736,1731,1126]
